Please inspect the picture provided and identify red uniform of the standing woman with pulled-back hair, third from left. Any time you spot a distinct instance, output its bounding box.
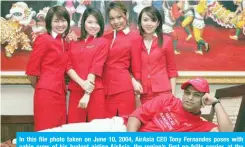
[103,28,141,117]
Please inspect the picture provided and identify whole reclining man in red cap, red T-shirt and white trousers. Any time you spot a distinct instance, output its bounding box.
[23,78,233,132]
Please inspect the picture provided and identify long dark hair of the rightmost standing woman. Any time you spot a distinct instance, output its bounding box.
[138,6,163,47]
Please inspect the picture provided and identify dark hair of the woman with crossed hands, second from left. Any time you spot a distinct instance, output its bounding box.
[80,6,105,40]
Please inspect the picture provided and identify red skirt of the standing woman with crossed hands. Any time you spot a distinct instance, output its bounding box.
[68,89,105,123]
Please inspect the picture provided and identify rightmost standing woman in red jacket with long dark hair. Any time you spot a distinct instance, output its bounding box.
[138,7,178,103]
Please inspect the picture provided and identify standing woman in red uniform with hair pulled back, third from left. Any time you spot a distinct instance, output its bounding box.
[103,1,142,117]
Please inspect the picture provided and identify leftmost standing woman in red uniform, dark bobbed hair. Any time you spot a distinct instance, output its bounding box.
[26,6,70,131]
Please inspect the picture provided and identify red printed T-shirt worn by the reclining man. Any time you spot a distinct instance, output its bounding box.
[124,94,217,132]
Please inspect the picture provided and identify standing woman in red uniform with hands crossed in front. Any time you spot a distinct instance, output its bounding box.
[67,7,109,123]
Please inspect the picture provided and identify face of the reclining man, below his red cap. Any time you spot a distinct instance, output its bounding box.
[182,85,204,114]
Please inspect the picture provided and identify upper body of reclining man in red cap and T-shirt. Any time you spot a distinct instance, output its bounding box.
[127,78,233,132]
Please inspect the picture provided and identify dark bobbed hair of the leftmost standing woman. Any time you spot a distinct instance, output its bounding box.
[45,6,70,36]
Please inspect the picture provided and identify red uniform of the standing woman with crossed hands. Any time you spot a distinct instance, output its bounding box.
[67,37,109,123]
